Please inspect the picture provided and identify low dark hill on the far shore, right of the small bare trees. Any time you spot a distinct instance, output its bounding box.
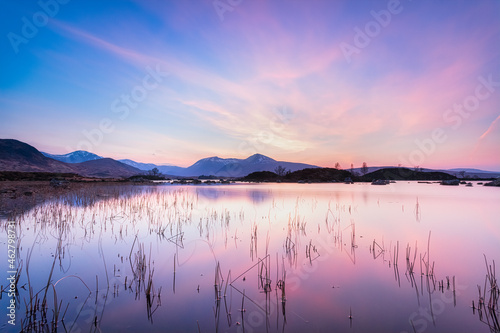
[359,168,457,181]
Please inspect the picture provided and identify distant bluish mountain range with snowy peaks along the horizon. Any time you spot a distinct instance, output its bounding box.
[0,139,500,178]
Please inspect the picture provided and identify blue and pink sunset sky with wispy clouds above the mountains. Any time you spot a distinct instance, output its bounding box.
[0,0,500,171]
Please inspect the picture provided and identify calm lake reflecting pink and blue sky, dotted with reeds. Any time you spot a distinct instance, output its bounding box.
[0,182,500,332]
